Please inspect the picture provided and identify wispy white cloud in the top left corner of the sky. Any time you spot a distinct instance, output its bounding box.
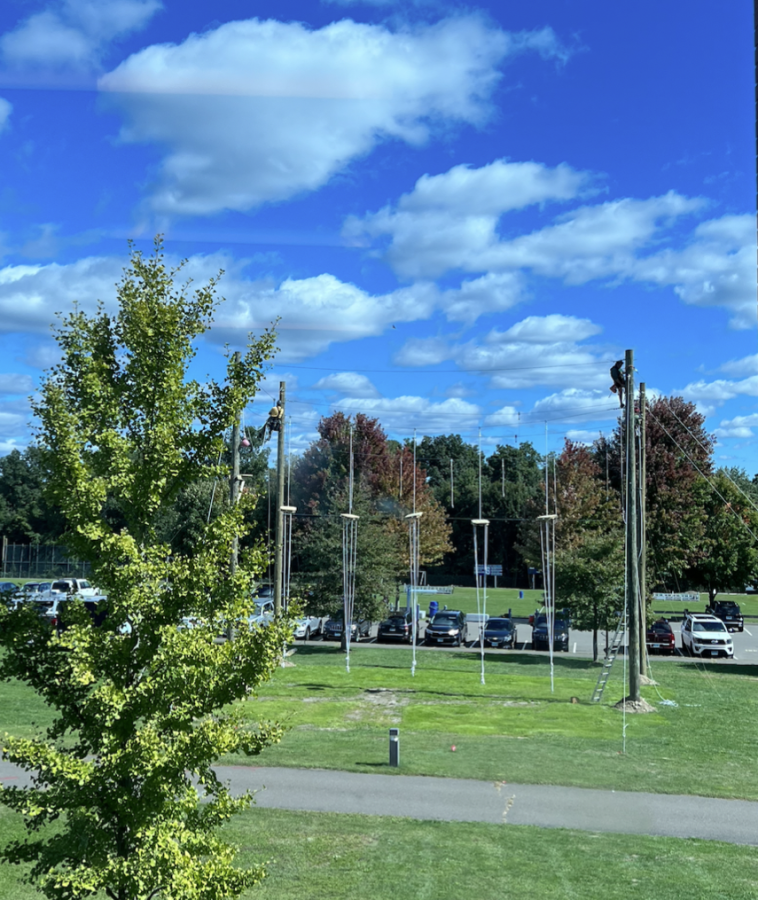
[0,0,161,69]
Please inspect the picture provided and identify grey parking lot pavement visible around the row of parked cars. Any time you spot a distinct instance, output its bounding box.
[312,618,758,665]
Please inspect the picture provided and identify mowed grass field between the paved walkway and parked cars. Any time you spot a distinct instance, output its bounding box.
[0,643,758,799]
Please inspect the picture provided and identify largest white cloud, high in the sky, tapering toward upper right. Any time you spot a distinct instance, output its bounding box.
[99,16,561,215]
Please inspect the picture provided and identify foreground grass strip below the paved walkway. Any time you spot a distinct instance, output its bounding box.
[0,809,758,900]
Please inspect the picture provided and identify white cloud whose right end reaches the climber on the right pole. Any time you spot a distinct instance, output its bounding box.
[394,314,610,389]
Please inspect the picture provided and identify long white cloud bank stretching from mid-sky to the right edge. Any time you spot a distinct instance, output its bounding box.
[344,160,756,328]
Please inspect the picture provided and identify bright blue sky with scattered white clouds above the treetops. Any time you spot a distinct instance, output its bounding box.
[0,0,758,464]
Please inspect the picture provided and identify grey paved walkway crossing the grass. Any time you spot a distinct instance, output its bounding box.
[0,762,758,845]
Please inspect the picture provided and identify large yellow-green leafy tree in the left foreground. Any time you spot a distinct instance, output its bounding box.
[0,241,287,900]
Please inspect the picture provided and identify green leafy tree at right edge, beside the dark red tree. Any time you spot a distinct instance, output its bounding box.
[687,470,758,603]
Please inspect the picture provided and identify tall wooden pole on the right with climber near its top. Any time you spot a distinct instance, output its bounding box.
[624,350,641,703]
